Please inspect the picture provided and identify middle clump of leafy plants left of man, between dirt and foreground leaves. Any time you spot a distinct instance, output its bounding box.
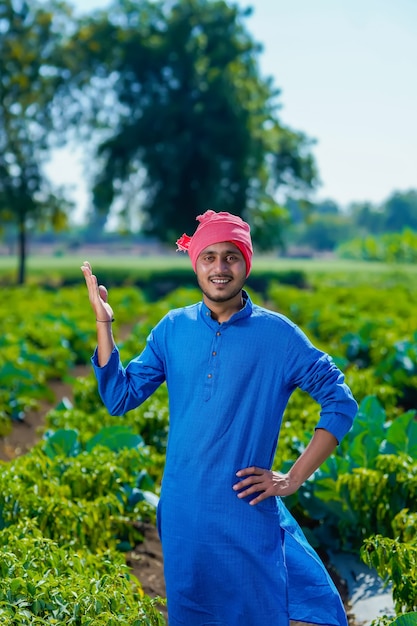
[0,426,157,551]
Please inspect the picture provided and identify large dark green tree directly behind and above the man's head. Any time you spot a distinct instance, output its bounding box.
[68,0,316,246]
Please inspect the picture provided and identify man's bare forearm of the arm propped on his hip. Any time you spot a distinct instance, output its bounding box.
[288,428,337,488]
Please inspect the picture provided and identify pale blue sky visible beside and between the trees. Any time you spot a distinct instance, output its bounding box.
[46,0,417,212]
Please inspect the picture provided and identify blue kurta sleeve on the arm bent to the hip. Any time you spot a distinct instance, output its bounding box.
[286,327,358,442]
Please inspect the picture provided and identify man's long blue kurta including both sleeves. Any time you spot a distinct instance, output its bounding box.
[93,294,357,626]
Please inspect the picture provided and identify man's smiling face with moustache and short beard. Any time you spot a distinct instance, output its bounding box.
[196,241,246,307]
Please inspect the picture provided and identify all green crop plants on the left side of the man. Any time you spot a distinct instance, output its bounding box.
[0,280,168,626]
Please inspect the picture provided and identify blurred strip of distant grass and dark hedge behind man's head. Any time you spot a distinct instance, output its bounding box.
[0,253,417,300]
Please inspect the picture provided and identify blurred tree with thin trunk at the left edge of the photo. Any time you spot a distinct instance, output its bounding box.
[0,0,73,284]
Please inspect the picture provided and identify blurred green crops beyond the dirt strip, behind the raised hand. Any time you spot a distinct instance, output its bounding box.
[0,286,153,424]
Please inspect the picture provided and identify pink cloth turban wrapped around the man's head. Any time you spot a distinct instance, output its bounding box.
[177,211,253,276]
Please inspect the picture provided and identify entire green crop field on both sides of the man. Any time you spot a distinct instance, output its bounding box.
[0,279,417,625]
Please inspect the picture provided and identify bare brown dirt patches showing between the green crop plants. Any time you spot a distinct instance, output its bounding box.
[0,367,357,626]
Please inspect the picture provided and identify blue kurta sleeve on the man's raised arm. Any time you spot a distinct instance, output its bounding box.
[91,332,165,415]
